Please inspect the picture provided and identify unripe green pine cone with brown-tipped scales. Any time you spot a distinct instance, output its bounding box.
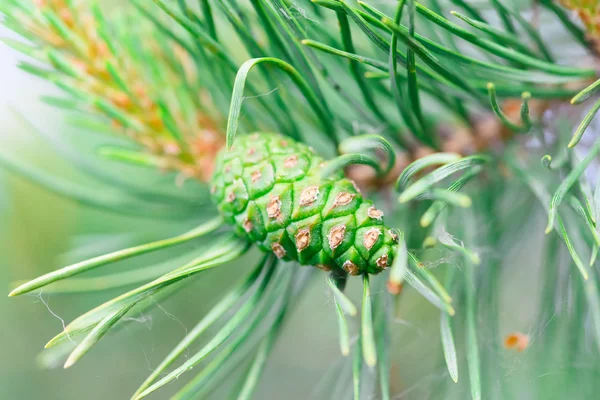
[211,133,398,275]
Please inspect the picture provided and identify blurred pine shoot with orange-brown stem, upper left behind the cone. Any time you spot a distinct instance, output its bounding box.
[4,0,223,181]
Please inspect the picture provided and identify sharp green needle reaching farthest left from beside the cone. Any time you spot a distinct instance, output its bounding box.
[9,217,223,297]
